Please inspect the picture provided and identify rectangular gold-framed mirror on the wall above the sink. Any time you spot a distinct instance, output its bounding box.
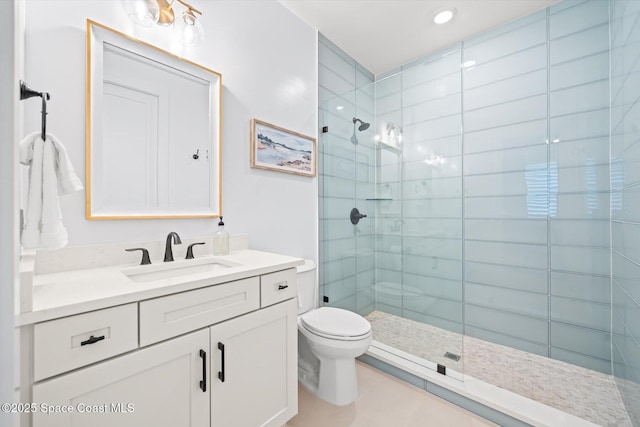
[87,21,222,219]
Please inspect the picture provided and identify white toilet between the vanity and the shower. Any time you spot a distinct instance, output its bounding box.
[298,260,372,406]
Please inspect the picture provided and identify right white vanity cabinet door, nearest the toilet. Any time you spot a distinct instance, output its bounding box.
[210,299,298,427]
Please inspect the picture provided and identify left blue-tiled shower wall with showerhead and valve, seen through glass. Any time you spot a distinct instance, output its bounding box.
[318,84,375,315]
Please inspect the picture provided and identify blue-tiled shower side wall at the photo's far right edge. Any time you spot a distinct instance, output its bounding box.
[610,0,640,425]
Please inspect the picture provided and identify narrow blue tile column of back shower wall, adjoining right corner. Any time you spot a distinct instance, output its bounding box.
[549,1,611,373]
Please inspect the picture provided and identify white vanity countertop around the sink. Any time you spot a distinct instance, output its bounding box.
[16,249,304,326]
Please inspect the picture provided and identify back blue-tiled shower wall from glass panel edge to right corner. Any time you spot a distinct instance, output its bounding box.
[462,1,610,372]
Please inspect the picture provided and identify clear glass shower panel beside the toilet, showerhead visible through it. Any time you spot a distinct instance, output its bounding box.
[319,54,464,379]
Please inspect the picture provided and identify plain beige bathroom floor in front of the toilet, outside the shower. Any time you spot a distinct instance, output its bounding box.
[286,362,496,427]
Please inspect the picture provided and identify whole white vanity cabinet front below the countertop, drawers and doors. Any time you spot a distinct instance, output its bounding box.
[32,268,298,427]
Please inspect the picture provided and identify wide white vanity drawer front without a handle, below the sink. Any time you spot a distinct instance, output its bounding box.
[140,277,260,346]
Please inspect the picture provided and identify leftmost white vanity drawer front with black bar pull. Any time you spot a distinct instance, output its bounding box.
[33,304,138,381]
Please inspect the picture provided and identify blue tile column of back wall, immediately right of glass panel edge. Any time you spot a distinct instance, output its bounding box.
[462,6,549,356]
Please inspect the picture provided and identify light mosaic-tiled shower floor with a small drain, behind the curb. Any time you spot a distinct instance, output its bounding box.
[367,311,631,427]
